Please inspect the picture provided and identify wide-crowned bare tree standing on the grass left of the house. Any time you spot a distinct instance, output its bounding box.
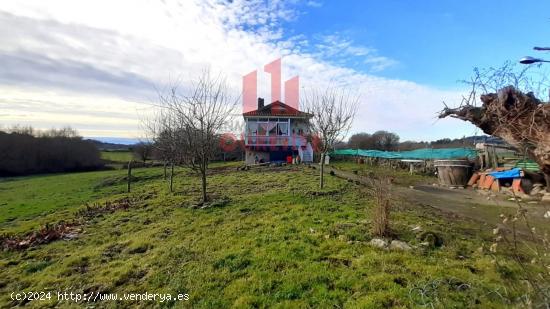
[149,71,238,203]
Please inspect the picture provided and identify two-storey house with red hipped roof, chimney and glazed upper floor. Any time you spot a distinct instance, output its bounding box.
[243,98,313,164]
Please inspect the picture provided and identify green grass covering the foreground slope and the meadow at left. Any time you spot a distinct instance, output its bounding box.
[0,163,544,308]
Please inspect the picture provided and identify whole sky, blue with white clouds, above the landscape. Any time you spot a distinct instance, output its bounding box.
[0,0,550,141]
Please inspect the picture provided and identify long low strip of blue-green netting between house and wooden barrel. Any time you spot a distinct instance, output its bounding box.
[332,148,477,160]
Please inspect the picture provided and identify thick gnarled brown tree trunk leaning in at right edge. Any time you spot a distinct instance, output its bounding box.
[439,86,550,186]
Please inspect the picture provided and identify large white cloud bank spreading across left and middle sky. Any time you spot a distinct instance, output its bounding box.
[0,0,473,140]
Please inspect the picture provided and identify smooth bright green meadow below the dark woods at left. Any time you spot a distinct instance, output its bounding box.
[0,169,174,233]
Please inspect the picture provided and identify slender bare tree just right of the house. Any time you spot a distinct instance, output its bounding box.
[302,87,359,189]
